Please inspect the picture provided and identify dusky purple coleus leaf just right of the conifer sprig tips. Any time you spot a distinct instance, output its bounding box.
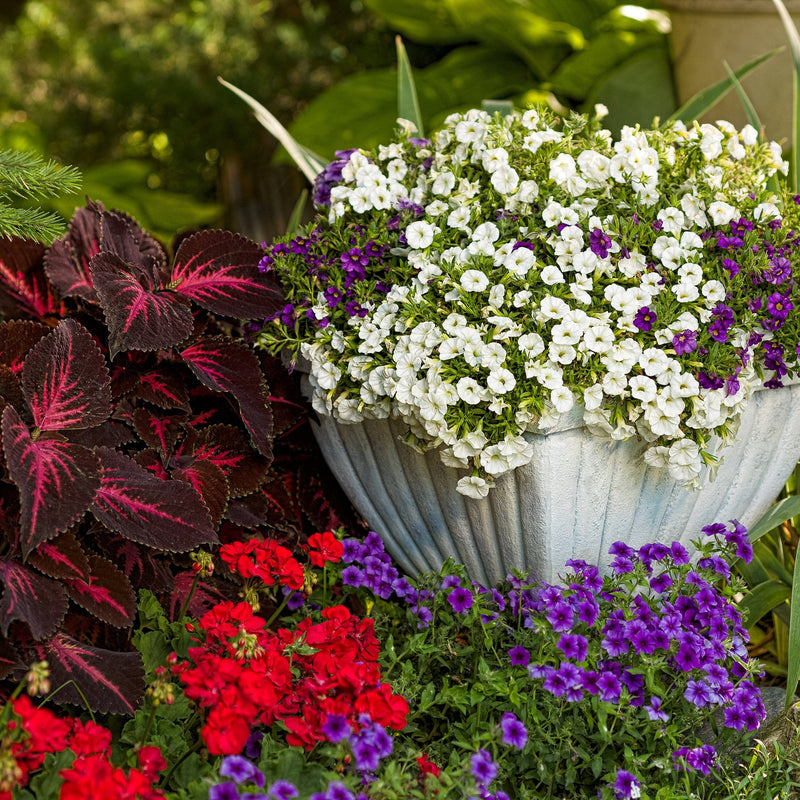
[44,203,102,302]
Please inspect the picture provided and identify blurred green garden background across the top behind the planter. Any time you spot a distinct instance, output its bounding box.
[0,0,675,241]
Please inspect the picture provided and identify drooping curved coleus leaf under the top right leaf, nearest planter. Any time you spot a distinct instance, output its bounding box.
[181,336,272,458]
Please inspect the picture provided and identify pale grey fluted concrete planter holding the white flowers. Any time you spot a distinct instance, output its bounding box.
[304,384,800,585]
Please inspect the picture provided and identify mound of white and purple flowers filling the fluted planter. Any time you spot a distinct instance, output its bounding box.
[260,108,800,498]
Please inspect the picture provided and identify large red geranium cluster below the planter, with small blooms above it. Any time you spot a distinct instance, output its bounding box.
[173,532,408,755]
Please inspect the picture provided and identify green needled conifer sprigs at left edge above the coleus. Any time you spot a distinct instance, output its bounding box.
[0,150,81,244]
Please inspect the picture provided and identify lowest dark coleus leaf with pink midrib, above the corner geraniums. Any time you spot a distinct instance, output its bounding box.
[34,634,145,714]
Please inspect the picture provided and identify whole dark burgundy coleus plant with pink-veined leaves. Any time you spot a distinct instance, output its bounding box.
[0,202,360,713]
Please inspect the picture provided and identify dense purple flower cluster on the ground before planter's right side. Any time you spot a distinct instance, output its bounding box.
[520,520,764,730]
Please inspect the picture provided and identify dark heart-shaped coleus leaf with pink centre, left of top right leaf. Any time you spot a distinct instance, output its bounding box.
[91,252,194,359]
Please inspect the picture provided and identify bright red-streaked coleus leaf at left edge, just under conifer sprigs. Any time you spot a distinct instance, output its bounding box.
[0,237,61,319]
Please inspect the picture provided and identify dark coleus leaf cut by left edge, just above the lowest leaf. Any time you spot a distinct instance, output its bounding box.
[0,559,68,639]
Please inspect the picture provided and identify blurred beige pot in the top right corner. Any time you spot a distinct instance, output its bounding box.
[661,0,800,145]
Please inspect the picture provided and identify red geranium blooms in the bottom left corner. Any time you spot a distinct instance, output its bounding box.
[0,695,166,800]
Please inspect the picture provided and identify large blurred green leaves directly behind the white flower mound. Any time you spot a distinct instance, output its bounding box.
[288,0,675,156]
